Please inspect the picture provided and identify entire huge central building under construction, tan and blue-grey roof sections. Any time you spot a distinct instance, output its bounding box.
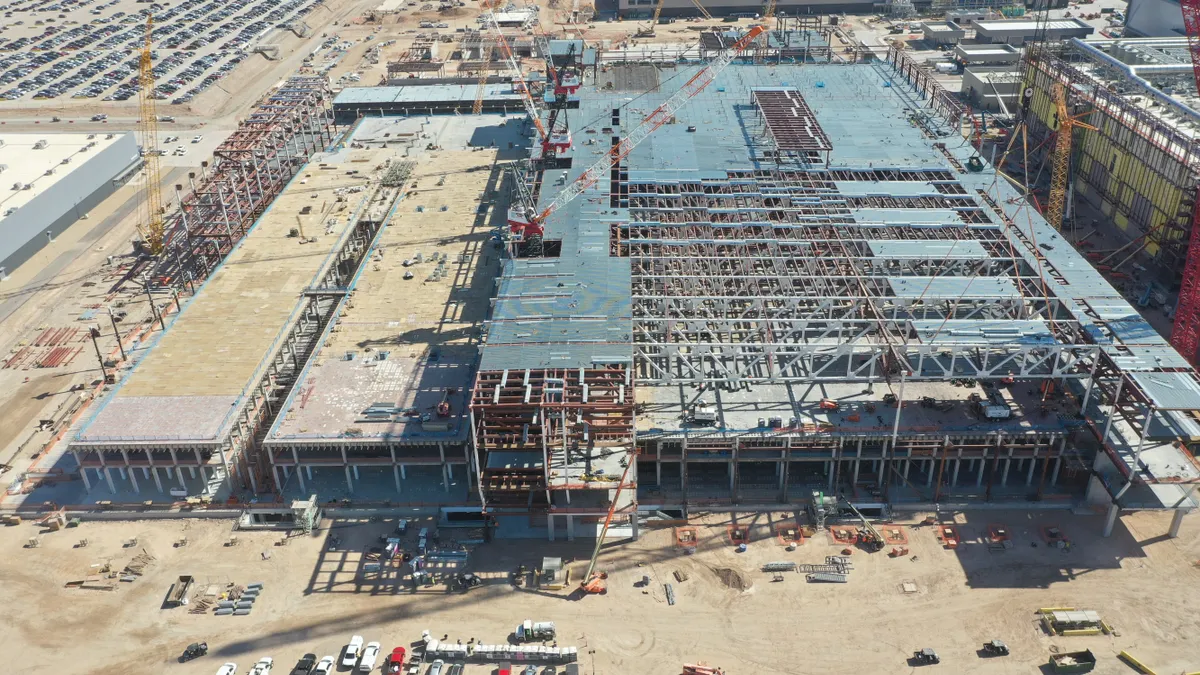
[65,38,1200,538]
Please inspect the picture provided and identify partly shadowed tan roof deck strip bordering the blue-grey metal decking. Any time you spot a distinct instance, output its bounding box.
[268,115,523,444]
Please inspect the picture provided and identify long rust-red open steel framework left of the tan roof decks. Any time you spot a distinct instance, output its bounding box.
[152,77,334,286]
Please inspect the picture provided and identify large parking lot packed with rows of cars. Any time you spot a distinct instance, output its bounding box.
[0,0,324,104]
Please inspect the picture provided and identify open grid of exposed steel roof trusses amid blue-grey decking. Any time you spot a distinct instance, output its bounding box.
[611,171,1097,384]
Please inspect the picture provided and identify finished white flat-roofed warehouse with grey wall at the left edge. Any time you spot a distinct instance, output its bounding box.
[0,133,142,279]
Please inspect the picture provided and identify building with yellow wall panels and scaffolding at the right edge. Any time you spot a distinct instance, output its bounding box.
[1022,37,1200,314]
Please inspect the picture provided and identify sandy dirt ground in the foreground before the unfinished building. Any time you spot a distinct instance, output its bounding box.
[0,512,1200,675]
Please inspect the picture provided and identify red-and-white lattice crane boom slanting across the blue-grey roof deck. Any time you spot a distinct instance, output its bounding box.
[534,25,767,226]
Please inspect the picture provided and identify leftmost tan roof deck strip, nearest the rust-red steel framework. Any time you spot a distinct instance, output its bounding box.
[78,150,382,442]
